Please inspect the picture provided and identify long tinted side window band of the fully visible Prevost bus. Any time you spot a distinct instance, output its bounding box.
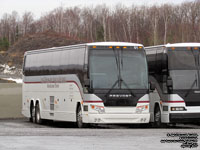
[24,47,85,78]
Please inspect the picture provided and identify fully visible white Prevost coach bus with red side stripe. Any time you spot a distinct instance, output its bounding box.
[22,42,150,127]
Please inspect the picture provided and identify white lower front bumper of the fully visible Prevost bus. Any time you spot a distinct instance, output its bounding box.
[83,113,150,124]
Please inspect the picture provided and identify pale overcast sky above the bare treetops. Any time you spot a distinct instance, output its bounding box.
[0,0,194,18]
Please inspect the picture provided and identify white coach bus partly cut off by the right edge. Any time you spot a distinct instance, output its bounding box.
[145,43,200,126]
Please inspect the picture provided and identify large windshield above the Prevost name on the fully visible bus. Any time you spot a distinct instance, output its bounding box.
[89,48,148,89]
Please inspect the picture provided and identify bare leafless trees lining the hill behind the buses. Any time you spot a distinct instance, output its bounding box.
[0,0,200,50]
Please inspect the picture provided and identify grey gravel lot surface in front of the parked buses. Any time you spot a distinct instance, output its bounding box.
[0,119,200,150]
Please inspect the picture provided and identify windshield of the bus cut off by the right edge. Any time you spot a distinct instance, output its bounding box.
[168,47,199,89]
